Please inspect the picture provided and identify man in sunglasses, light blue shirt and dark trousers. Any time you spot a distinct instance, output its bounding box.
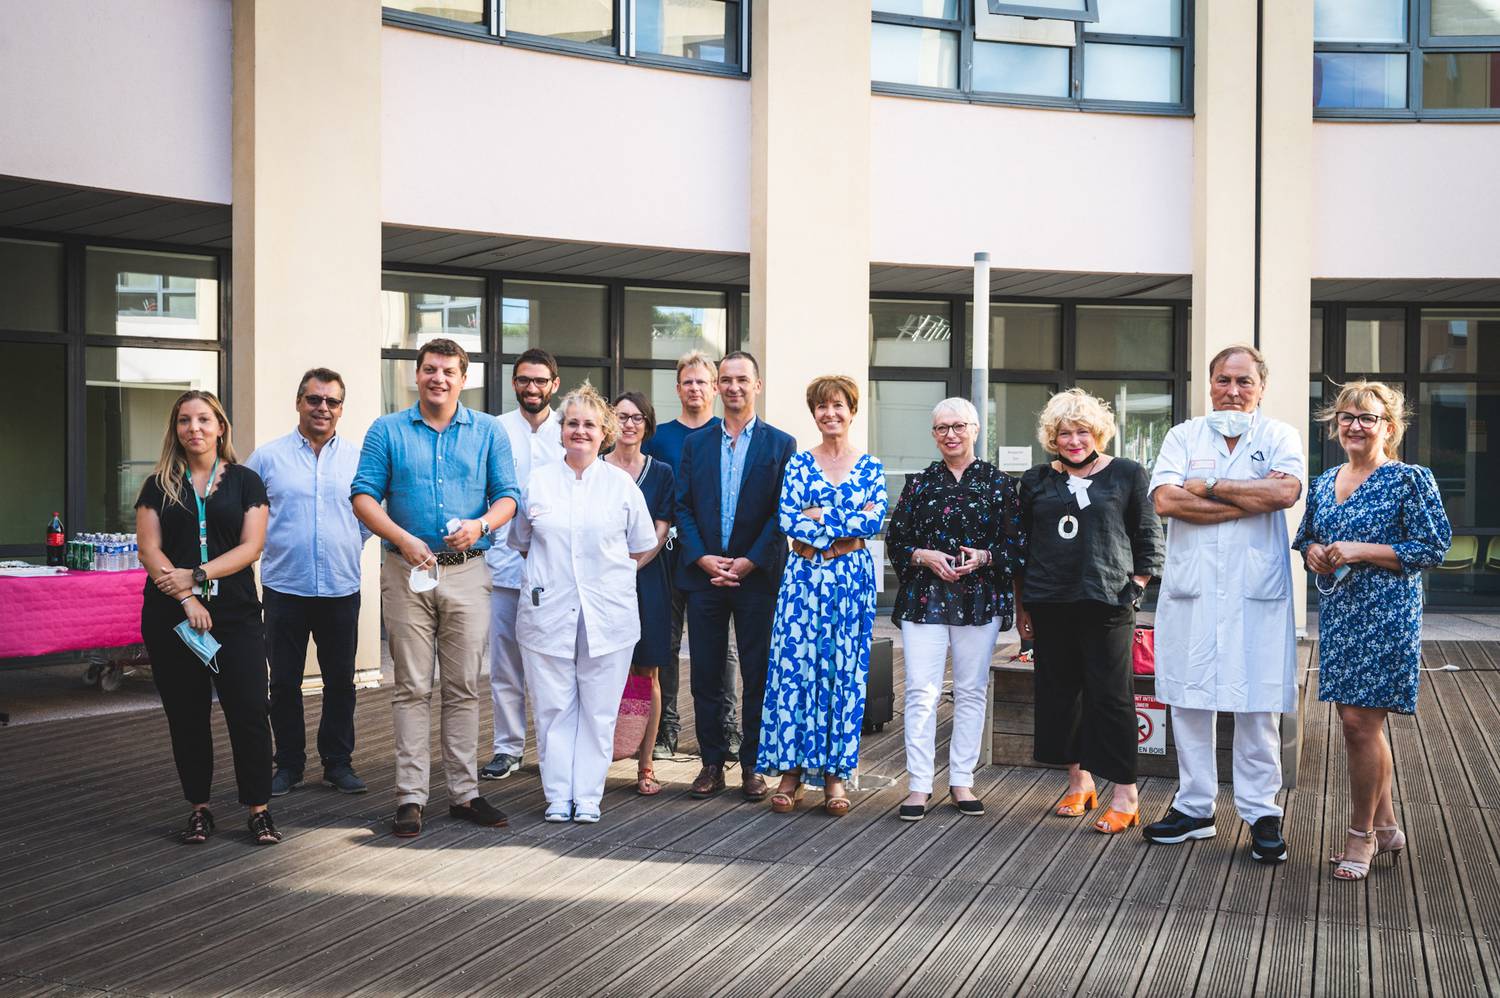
[245,368,371,797]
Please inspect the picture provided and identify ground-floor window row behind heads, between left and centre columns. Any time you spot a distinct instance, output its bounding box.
[381,270,744,422]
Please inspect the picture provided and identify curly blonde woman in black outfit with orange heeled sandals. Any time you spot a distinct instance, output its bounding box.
[1016,389,1164,834]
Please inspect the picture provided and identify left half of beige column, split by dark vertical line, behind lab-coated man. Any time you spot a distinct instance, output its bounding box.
[1188,3,1260,416]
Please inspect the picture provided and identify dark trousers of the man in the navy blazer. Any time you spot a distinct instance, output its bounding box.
[687,585,776,773]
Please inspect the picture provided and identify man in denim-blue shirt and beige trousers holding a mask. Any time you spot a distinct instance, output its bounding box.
[350,339,521,837]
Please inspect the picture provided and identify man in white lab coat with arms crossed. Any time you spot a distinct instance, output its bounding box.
[1143,347,1307,863]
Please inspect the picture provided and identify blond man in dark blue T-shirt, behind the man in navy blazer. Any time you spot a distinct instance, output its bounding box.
[641,350,740,759]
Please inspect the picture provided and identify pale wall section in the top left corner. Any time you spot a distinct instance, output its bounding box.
[0,0,231,203]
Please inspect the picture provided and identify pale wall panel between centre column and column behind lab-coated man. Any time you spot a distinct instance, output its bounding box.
[870,96,1193,273]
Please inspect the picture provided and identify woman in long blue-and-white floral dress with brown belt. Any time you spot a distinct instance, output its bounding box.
[756,377,887,815]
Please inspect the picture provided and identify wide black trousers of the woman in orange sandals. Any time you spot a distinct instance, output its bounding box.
[1026,600,1139,783]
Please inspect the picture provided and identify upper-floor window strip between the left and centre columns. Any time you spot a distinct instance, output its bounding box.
[386,0,750,75]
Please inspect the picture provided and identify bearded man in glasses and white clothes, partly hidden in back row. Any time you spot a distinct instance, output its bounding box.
[479,348,563,780]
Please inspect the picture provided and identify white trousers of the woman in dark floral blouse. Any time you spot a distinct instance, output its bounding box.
[902,617,1001,794]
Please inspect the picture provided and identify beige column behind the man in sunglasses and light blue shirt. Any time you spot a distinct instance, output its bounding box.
[231,0,381,678]
